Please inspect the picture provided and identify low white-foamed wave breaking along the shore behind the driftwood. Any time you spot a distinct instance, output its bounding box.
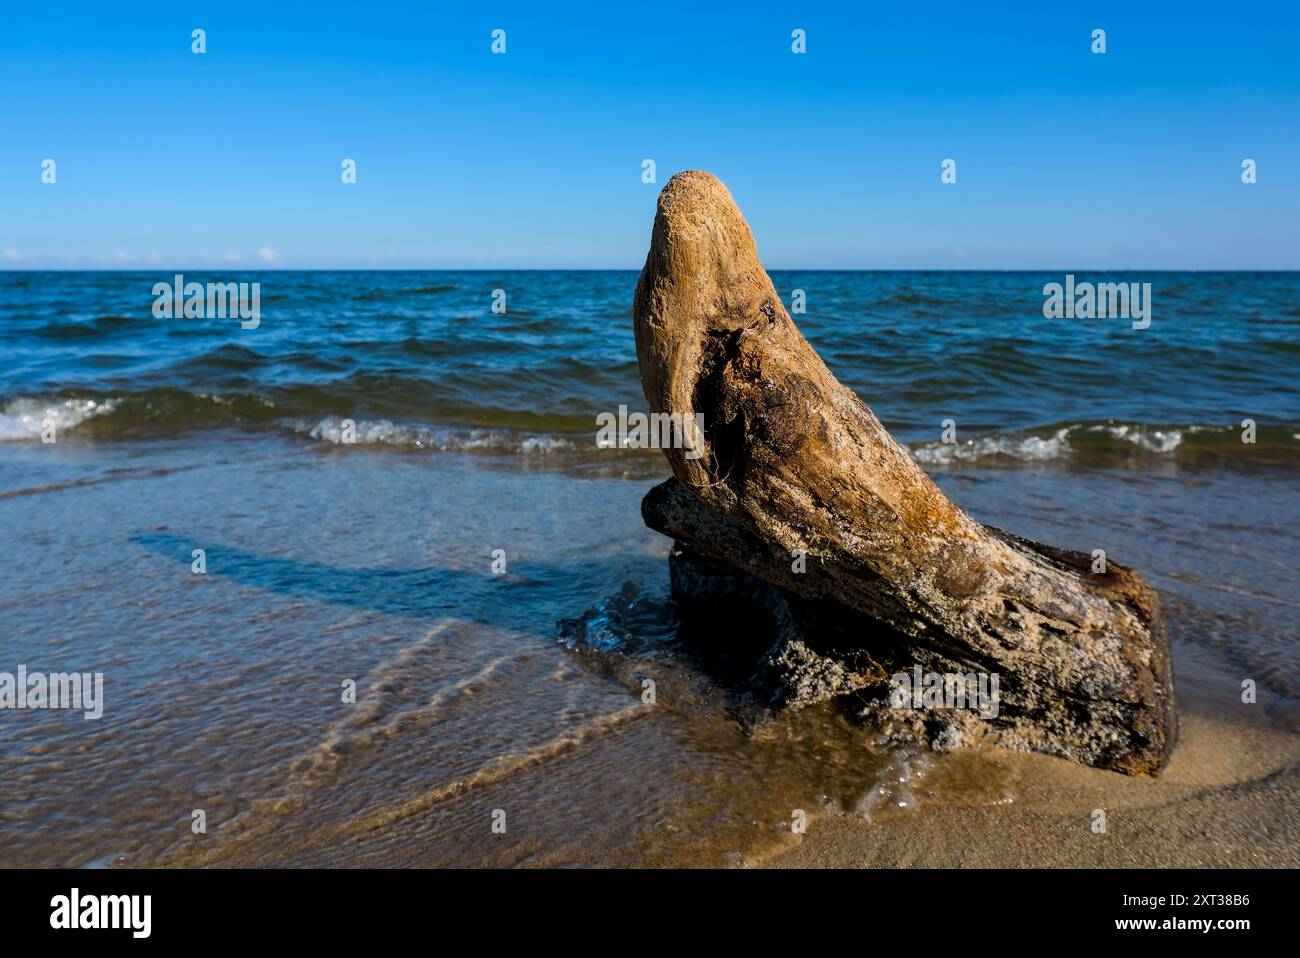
[0,387,1300,469]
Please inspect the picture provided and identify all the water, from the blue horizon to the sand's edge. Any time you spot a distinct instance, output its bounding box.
[0,270,1300,866]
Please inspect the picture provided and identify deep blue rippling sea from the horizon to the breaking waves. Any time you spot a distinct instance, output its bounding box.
[0,270,1300,468]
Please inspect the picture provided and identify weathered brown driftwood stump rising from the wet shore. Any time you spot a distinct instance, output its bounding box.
[634,172,1178,773]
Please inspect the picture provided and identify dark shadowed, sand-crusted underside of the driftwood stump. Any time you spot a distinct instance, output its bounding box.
[642,480,1178,775]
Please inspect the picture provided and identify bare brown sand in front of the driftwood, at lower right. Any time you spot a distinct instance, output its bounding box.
[755,714,1300,868]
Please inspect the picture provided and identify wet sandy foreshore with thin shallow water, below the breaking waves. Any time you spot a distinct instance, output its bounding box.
[0,433,1300,867]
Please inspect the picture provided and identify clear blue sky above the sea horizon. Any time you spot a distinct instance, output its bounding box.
[0,0,1300,269]
